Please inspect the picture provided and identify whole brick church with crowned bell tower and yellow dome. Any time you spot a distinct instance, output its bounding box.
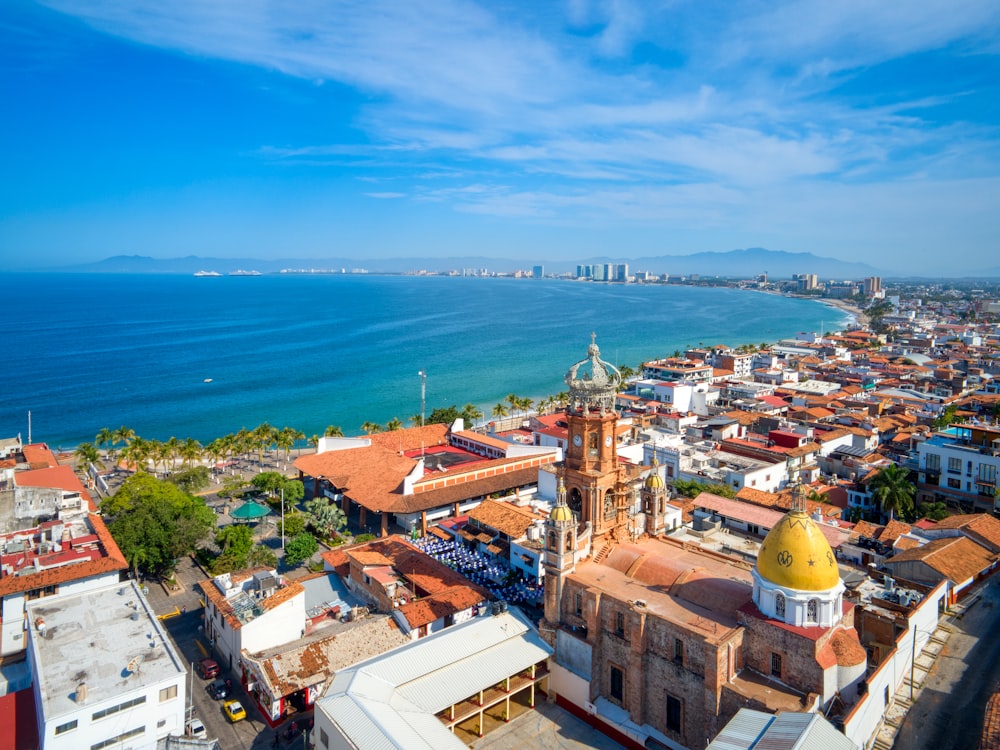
[541,340,866,748]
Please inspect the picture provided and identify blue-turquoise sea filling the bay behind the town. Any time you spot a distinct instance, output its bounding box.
[0,274,846,448]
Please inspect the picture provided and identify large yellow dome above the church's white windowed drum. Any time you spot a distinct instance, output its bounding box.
[757,510,840,591]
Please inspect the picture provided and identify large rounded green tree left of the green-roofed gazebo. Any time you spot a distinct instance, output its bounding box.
[101,473,215,574]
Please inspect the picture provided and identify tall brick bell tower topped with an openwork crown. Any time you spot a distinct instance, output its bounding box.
[562,334,630,538]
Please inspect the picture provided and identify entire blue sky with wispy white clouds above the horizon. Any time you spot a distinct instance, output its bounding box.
[0,0,1000,272]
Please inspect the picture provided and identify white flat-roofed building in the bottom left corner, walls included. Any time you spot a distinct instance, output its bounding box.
[28,581,188,750]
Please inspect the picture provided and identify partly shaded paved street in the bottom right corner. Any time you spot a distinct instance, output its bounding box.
[893,576,1000,750]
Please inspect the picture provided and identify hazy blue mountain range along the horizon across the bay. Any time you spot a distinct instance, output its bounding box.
[64,248,899,280]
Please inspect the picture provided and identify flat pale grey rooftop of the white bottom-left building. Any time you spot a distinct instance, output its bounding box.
[28,581,187,719]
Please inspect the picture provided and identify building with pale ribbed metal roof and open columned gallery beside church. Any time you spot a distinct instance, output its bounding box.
[313,605,552,750]
